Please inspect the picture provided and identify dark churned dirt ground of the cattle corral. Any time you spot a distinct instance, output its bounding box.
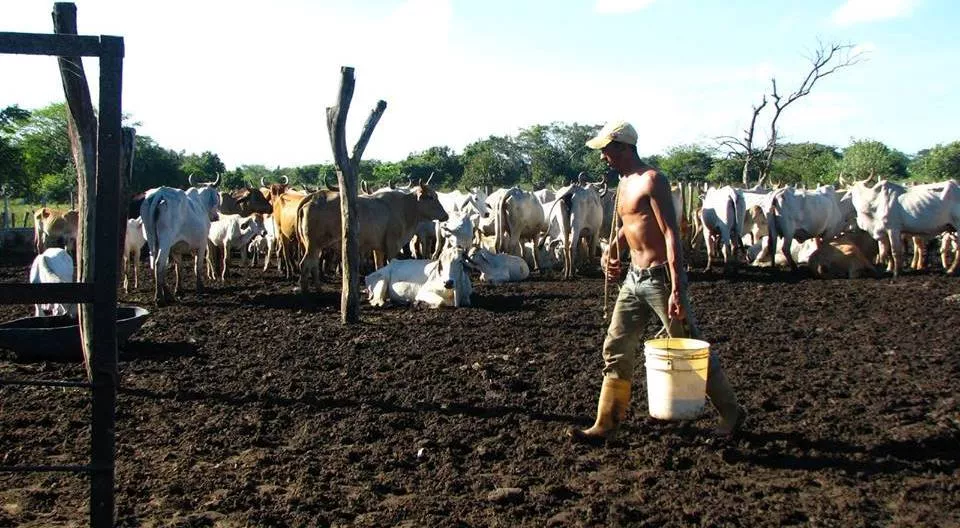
[0,253,960,526]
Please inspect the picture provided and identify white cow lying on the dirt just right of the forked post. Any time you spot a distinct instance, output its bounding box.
[365,247,473,308]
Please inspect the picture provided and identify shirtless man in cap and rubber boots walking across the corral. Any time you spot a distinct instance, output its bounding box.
[568,121,747,443]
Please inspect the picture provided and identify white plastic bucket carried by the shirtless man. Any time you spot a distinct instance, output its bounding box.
[643,337,710,420]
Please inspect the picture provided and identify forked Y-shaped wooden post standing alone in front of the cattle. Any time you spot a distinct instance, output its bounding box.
[327,66,387,324]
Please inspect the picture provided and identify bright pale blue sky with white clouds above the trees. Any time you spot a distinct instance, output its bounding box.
[0,0,960,169]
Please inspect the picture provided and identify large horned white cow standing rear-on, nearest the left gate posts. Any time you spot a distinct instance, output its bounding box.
[140,178,220,306]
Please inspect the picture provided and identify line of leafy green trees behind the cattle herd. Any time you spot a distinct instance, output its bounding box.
[0,103,960,202]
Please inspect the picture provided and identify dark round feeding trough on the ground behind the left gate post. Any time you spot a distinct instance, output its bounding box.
[0,306,150,361]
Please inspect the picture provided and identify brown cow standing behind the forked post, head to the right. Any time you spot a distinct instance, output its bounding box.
[297,185,447,292]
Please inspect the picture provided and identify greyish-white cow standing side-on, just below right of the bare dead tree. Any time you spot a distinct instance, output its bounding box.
[758,185,845,269]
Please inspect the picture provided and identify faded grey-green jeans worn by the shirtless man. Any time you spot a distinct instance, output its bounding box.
[603,264,738,419]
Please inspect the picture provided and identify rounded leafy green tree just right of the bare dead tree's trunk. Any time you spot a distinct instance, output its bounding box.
[770,143,841,187]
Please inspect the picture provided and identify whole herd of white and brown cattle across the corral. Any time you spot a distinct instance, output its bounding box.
[24,175,960,311]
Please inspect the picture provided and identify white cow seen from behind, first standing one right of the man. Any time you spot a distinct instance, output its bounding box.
[700,185,746,270]
